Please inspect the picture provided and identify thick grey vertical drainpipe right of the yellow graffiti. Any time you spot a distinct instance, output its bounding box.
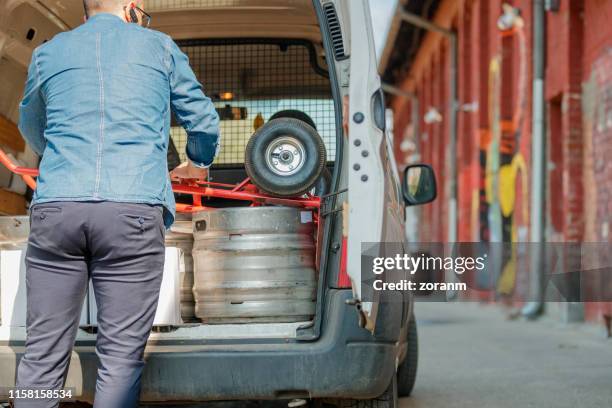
[521,0,547,318]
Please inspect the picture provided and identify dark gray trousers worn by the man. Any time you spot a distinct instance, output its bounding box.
[15,202,165,408]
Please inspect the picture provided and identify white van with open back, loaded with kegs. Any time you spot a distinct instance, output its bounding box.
[0,0,434,407]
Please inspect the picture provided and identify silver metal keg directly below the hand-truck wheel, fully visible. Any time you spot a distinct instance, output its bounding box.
[193,207,316,323]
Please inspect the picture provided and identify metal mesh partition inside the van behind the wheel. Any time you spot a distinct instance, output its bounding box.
[171,40,336,166]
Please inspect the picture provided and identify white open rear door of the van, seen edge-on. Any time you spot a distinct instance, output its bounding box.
[342,0,387,331]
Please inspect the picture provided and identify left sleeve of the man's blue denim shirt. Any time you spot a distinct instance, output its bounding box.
[18,50,47,156]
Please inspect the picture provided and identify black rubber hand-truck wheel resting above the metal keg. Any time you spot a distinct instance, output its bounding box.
[244,119,327,197]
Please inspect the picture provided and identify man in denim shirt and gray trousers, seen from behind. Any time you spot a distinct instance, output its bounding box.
[15,0,219,408]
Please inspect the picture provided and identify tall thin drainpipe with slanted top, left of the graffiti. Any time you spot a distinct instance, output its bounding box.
[399,10,459,242]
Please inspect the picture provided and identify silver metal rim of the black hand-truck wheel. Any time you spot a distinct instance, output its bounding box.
[266,136,306,176]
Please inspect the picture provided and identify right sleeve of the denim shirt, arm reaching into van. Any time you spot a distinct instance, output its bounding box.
[169,39,220,168]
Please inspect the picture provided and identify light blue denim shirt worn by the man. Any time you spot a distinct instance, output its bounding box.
[19,13,219,227]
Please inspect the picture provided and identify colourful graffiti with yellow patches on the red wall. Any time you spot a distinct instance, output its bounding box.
[479,17,528,296]
